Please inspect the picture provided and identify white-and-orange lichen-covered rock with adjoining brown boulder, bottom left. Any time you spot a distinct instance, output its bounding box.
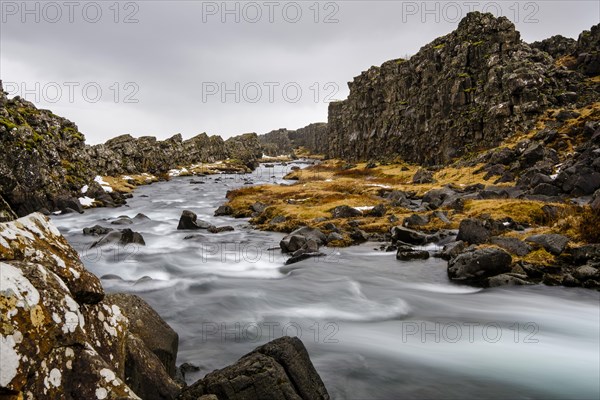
[0,214,180,399]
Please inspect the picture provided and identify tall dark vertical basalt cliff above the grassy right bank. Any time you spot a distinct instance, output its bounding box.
[292,12,598,164]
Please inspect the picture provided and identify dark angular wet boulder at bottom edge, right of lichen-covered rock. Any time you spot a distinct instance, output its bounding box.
[178,336,329,400]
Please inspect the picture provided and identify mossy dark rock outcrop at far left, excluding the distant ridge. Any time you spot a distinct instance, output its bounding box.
[0,81,94,216]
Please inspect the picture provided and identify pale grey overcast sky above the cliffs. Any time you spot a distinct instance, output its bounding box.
[0,0,600,143]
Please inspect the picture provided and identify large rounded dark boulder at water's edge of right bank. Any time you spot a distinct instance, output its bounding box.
[448,247,512,284]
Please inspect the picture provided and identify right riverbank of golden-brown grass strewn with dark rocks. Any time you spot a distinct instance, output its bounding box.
[219,103,600,289]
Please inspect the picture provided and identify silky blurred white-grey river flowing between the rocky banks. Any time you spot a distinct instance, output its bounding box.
[52,162,600,399]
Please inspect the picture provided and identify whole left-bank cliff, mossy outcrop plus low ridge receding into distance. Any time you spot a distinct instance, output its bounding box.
[0,81,262,217]
